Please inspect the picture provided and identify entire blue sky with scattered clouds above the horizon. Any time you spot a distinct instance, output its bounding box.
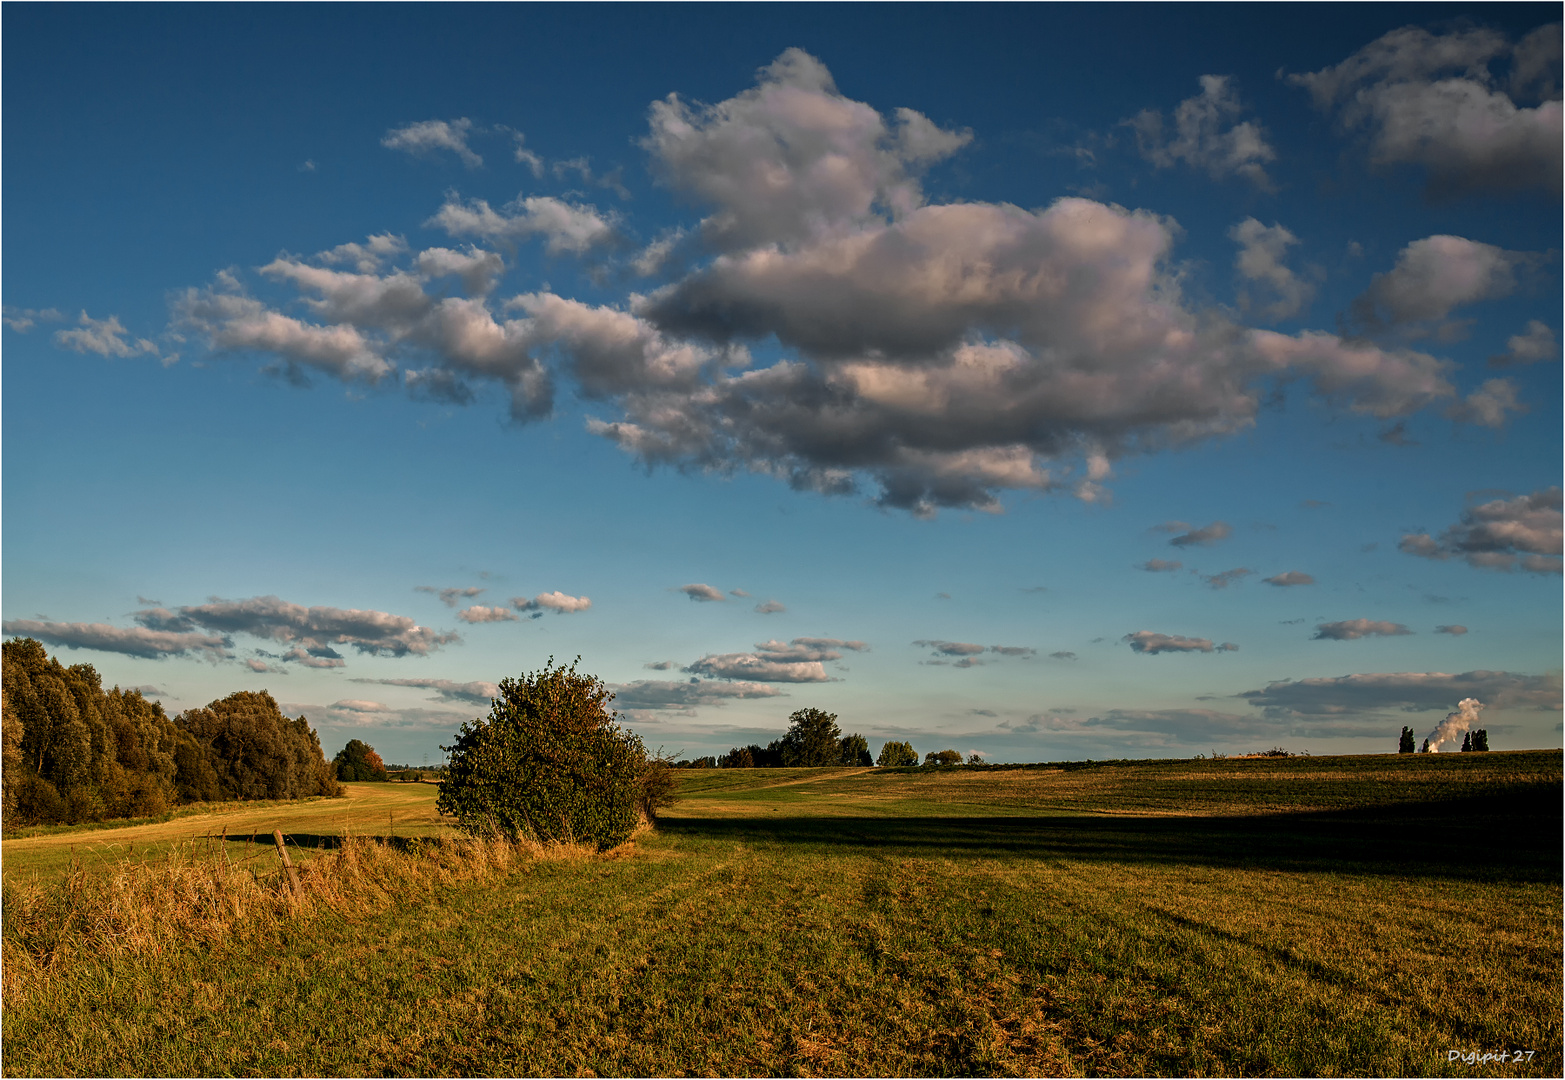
[0,5,1562,764]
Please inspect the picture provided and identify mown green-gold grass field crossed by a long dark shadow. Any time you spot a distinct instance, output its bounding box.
[3,751,1562,1075]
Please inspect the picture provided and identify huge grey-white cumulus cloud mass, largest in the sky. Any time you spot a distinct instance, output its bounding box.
[165,50,1506,515]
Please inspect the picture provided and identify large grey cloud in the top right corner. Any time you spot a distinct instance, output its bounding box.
[1288,25,1562,194]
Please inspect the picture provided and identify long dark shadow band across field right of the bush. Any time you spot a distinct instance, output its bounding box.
[657,787,1562,881]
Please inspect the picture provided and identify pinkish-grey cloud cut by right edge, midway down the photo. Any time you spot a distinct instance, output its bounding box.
[1398,487,1562,574]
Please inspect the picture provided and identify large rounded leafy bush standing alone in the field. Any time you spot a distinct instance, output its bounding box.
[435,656,673,848]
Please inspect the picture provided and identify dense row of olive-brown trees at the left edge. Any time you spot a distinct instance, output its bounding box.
[0,637,341,826]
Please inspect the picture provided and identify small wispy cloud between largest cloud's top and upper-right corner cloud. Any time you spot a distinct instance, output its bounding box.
[1128,75,1277,191]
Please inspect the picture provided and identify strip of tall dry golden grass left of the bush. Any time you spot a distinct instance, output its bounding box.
[0,836,634,1003]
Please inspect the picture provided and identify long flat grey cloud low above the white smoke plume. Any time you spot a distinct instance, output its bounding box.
[1239,671,1560,717]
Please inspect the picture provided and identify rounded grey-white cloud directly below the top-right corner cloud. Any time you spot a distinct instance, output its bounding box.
[1351,236,1531,337]
